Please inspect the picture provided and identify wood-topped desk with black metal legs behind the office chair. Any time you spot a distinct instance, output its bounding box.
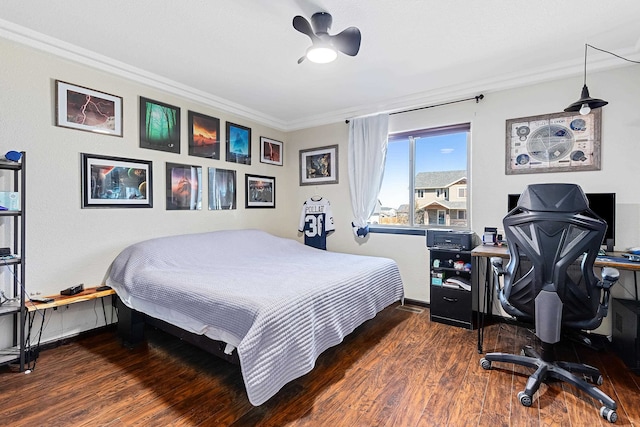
[471,245,640,353]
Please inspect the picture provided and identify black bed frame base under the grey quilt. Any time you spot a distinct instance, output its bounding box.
[116,298,240,365]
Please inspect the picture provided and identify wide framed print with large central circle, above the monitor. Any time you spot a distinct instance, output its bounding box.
[505,109,602,175]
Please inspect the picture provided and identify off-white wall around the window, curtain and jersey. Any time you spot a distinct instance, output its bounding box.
[289,66,640,332]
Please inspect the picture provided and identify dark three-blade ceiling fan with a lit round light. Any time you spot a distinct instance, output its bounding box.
[293,12,361,64]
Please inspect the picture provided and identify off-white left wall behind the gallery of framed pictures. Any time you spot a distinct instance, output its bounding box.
[0,38,293,347]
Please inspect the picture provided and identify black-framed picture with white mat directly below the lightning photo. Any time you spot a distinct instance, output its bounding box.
[81,153,153,208]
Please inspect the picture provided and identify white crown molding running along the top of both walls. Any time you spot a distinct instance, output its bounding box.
[0,19,640,132]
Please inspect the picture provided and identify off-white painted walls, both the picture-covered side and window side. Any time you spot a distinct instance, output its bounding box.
[0,34,640,346]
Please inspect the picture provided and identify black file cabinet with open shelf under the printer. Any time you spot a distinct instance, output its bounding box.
[429,248,475,329]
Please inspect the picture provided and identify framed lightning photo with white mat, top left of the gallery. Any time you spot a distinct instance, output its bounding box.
[56,80,122,137]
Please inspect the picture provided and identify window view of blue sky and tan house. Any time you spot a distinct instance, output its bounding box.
[369,123,470,228]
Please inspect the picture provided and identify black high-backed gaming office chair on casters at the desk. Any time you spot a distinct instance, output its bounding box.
[480,184,619,423]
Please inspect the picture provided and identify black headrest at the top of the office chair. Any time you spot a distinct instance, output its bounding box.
[518,184,589,212]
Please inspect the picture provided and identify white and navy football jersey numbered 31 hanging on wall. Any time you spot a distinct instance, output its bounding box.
[298,197,335,250]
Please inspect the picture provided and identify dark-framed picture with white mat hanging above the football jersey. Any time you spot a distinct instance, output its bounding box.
[300,145,338,185]
